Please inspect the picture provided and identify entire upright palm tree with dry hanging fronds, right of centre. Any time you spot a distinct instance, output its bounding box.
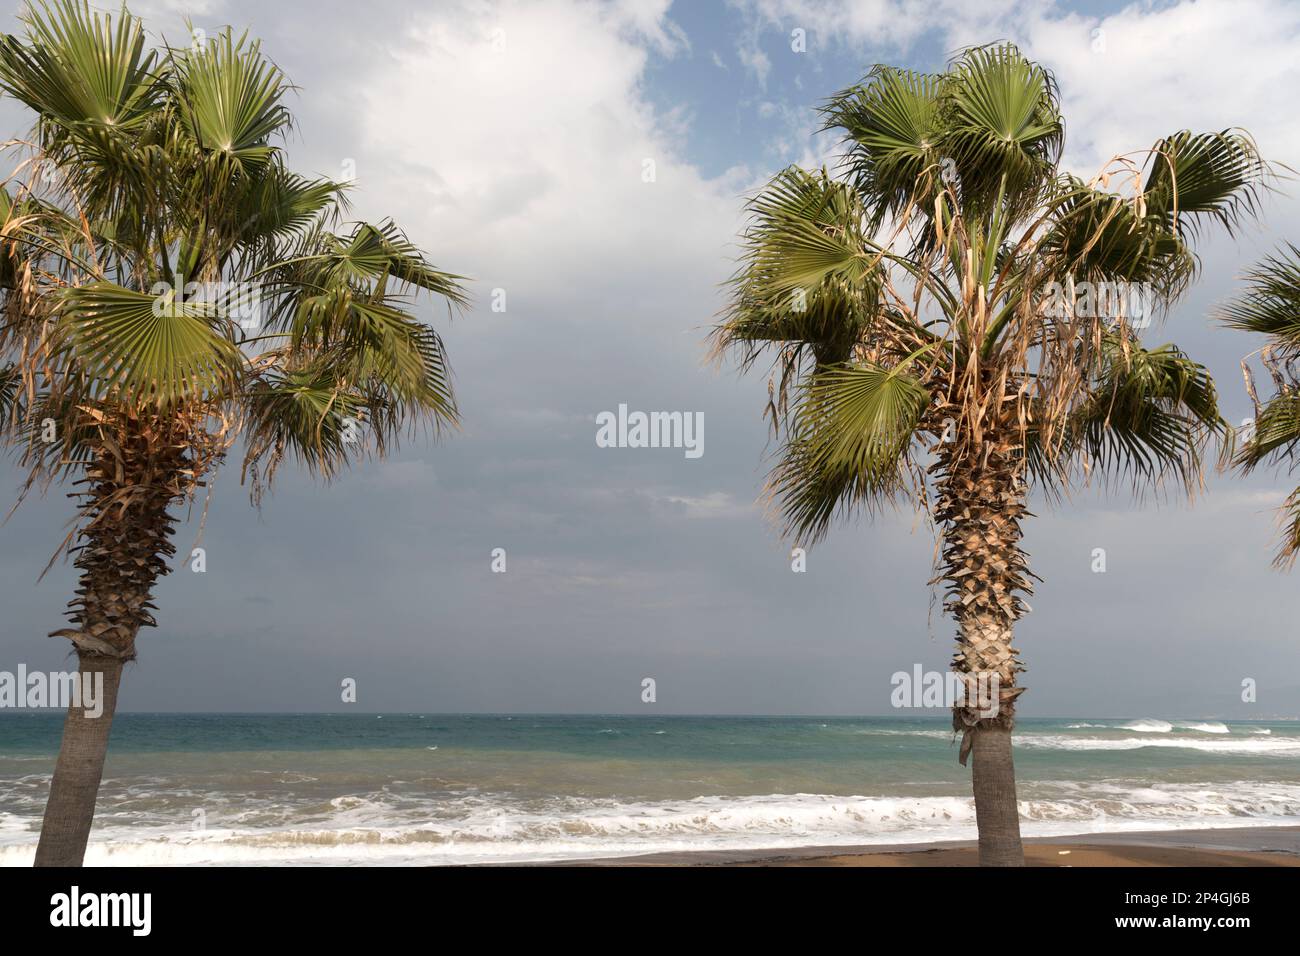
[712,44,1268,865]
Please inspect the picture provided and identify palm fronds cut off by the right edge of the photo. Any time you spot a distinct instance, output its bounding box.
[1222,243,1300,567]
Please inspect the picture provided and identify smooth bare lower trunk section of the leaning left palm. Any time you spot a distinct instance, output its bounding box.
[36,653,125,866]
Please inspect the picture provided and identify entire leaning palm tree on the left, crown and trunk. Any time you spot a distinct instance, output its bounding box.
[0,0,463,865]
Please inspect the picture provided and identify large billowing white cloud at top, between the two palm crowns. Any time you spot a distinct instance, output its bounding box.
[359,0,738,312]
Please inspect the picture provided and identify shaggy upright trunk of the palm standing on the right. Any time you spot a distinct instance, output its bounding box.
[935,433,1032,866]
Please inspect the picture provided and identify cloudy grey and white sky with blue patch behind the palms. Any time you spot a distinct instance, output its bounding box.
[0,0,1300,718]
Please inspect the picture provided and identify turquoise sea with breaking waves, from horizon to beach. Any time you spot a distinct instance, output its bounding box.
[0,711,1300,865]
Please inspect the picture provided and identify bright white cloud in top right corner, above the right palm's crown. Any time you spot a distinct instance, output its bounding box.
[737,0,1300,174]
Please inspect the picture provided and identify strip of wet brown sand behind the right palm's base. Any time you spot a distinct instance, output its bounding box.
[553,825,1300,868]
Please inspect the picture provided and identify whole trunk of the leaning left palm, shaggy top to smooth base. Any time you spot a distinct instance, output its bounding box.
[36,416,187,866]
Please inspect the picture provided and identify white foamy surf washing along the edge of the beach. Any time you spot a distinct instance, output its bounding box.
[0,780,1300,865]
